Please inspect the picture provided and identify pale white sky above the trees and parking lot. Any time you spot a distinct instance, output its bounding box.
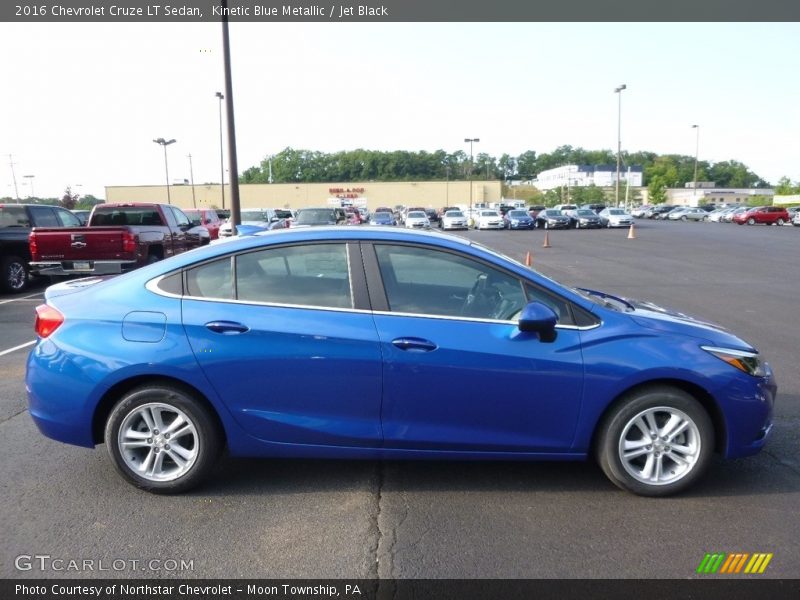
[0,23,800,198]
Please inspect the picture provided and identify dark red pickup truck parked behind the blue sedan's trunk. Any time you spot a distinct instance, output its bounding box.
[28,203,210,276]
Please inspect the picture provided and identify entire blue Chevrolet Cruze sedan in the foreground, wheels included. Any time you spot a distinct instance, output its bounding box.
[27,227,776,496]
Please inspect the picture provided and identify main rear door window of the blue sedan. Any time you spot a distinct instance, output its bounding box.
[236,243,353,308]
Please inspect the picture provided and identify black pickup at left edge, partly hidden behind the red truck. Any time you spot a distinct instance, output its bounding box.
[0,204,81,293]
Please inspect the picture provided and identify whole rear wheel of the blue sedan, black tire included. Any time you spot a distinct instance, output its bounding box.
[105,385,222,494]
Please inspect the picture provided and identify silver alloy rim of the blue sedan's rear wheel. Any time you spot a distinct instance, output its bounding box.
[117,402,200,481]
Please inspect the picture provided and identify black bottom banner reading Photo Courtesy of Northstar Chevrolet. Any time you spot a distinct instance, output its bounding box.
[0,577,800,600]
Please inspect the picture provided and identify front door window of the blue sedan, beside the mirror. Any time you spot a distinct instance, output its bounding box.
[375,244,526,320]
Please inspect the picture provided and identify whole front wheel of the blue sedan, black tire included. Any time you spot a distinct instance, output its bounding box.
[595,386,714,496]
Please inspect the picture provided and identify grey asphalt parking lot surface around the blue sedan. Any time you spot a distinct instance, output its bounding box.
[0,221,800,578]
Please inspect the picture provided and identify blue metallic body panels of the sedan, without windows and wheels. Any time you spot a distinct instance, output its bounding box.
[26,227,776,466]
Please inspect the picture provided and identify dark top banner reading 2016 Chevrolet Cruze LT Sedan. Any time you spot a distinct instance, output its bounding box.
[0,0,800,23]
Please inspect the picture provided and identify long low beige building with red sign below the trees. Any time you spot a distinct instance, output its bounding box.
[106,181,502,210]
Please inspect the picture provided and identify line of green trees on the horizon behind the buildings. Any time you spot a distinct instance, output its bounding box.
[239,146,770,188]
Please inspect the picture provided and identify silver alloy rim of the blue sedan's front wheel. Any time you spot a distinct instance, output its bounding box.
[618,406,701,485]
